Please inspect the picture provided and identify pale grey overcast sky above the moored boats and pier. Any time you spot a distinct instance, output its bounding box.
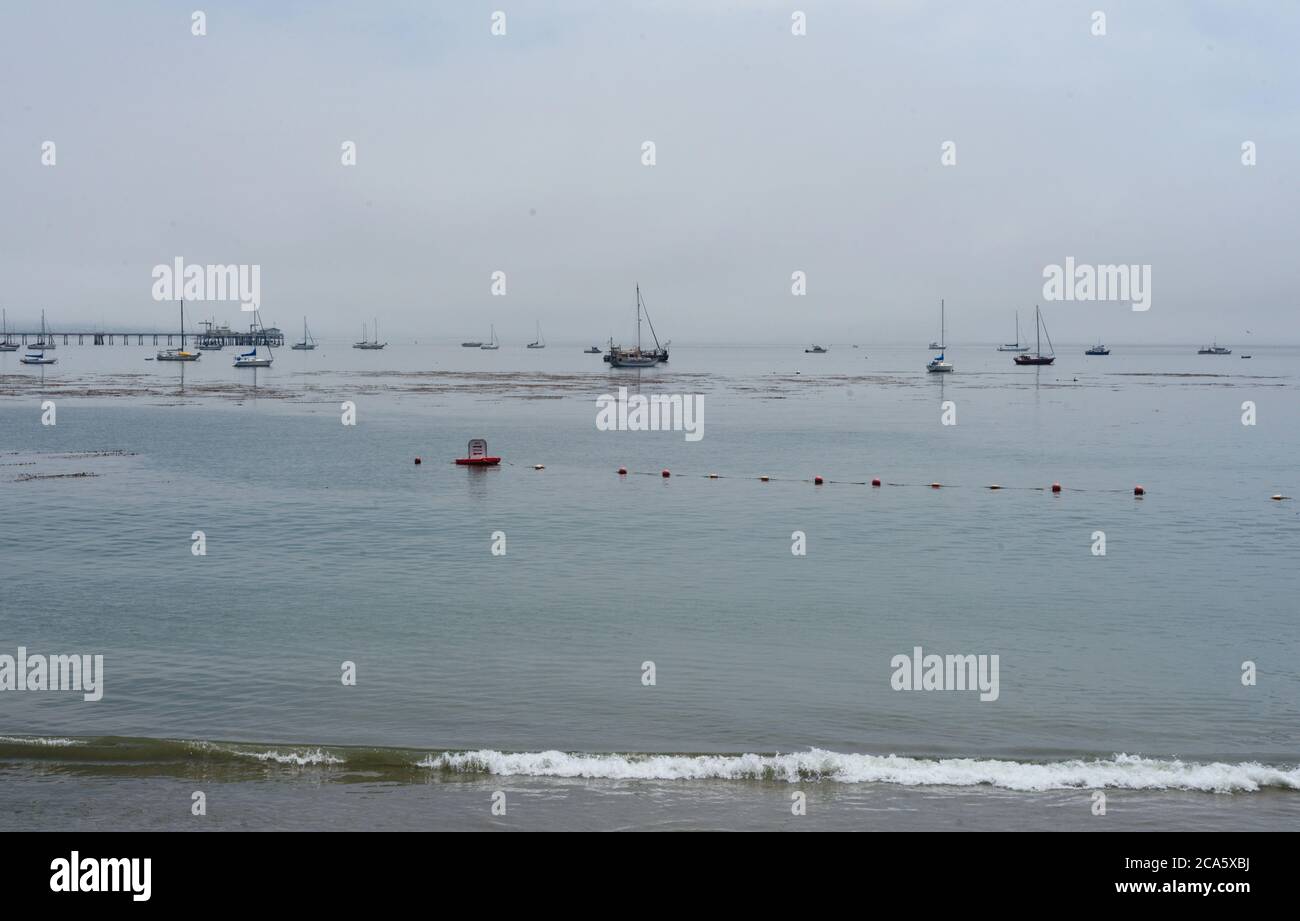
[0,0,1300,345]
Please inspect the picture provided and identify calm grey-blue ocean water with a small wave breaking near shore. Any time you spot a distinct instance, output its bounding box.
[0,342,1300,830]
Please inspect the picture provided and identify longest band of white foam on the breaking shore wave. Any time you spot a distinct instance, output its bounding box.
[419,748,1300,794]
